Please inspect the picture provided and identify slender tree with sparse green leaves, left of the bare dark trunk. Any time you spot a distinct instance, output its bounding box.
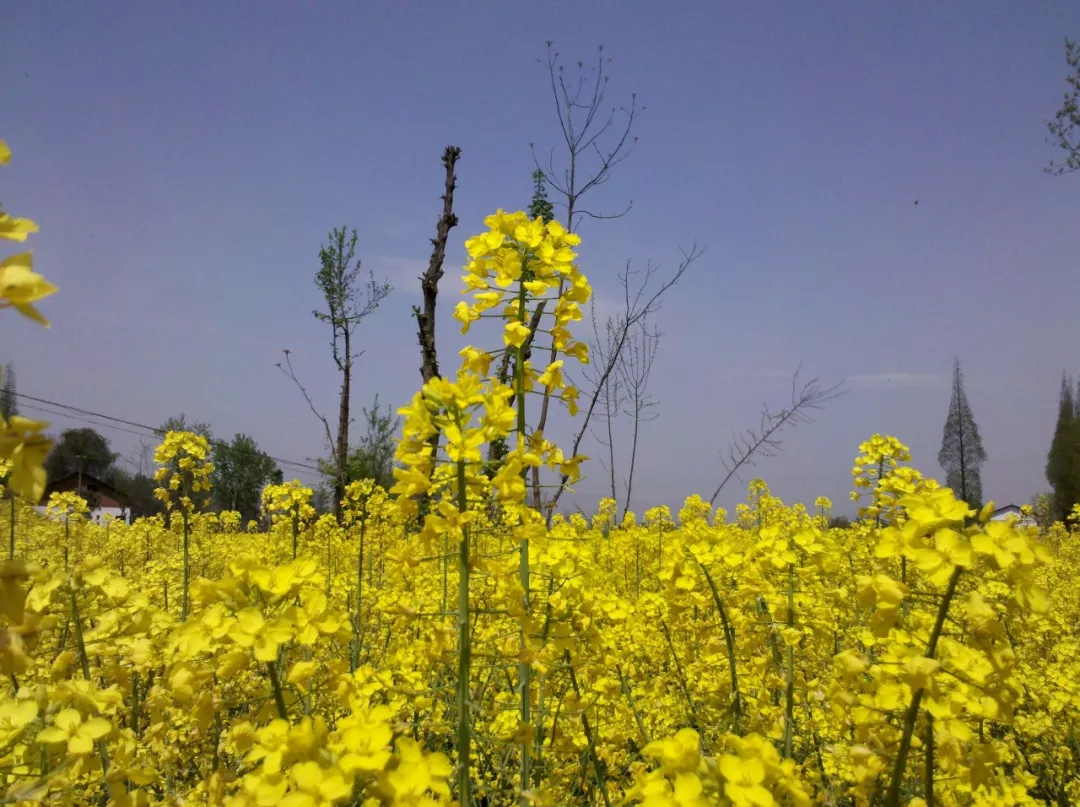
[278,227,392,519]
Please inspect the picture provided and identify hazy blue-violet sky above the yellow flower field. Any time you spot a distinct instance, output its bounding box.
[0,0,1080,518]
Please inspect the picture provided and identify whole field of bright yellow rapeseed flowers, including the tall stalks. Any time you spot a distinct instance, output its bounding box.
[0,137,1080,807]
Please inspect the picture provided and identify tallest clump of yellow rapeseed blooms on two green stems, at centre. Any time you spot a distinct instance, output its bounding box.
[391,211,590,805]
